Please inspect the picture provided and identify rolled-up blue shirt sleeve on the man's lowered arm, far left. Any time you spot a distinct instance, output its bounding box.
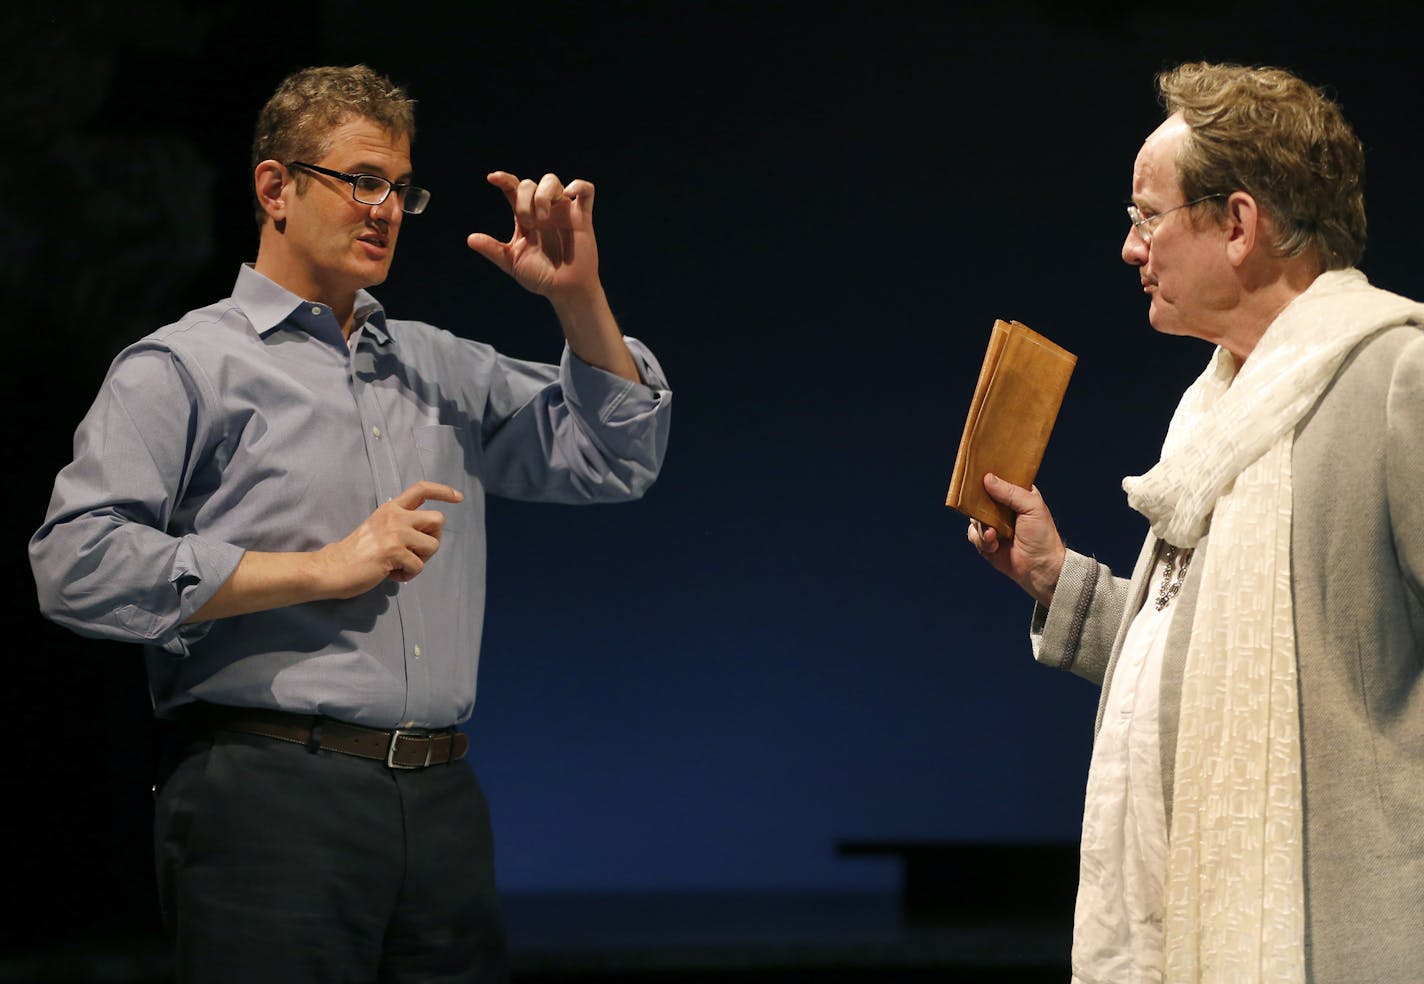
[30,345,244,655]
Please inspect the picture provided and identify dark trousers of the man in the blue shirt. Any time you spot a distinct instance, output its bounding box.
[154,732,508,984]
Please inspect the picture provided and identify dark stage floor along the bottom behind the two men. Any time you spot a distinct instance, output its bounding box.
[0,893,1071,984]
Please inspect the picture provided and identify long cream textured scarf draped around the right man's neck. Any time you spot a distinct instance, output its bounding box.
[1122,269,1424,984]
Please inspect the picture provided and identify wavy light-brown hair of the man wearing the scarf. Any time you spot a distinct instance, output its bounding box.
[1156,61,1366,269]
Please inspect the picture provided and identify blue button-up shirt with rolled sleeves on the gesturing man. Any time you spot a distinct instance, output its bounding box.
[30,266,672,728]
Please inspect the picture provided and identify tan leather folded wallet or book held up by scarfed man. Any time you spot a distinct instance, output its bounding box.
[944,320,1078,537]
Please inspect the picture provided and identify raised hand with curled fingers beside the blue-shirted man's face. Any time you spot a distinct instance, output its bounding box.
[467,171,600,300]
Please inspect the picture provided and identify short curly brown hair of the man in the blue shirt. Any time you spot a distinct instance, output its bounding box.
[252,66,416,228]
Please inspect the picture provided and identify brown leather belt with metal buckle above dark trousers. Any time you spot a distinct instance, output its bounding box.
[182,703,470,769]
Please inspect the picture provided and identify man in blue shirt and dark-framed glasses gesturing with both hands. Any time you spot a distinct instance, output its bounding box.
[30,66,671,981]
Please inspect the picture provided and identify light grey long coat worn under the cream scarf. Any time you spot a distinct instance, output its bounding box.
[1034,304,1424,983]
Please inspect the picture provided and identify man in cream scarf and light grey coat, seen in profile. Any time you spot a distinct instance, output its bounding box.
[968,64,1424,984]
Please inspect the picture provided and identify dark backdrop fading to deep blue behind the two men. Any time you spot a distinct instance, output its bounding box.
[11,0,1424,934]
